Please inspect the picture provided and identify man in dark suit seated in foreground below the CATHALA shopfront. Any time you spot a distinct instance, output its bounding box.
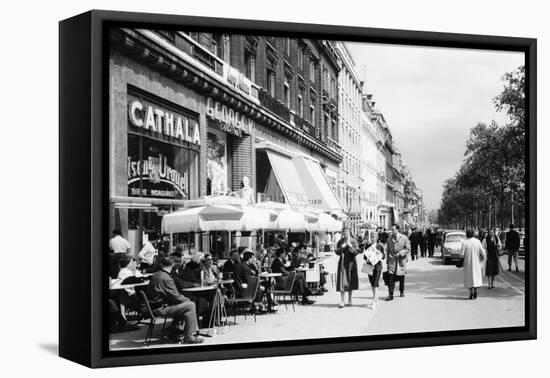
[147,256,204,344]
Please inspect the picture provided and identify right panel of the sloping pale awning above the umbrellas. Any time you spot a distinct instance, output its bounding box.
[292,156,344,213]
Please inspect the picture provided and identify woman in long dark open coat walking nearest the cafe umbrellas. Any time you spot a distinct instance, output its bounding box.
[336,227,359,308]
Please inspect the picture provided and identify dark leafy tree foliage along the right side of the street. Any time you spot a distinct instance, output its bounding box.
[438,66,525,227]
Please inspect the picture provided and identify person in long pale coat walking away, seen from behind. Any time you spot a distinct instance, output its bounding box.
[461,229,486,299]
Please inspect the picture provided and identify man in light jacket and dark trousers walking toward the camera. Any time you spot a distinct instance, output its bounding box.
[386,224,411,301]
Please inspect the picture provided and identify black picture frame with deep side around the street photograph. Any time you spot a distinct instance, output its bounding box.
[59,10,537,368]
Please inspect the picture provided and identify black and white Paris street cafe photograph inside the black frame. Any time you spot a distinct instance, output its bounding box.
[106,25,532,353]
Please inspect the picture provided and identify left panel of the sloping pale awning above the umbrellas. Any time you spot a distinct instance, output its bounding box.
[266,149,307,207]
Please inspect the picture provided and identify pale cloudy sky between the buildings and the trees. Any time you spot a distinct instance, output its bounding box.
[346,43,524,210]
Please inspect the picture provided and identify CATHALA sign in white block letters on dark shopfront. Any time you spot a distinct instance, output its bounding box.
[128,99,201,146]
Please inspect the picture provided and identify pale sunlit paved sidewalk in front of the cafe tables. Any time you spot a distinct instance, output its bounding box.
[111,250,525,349]
